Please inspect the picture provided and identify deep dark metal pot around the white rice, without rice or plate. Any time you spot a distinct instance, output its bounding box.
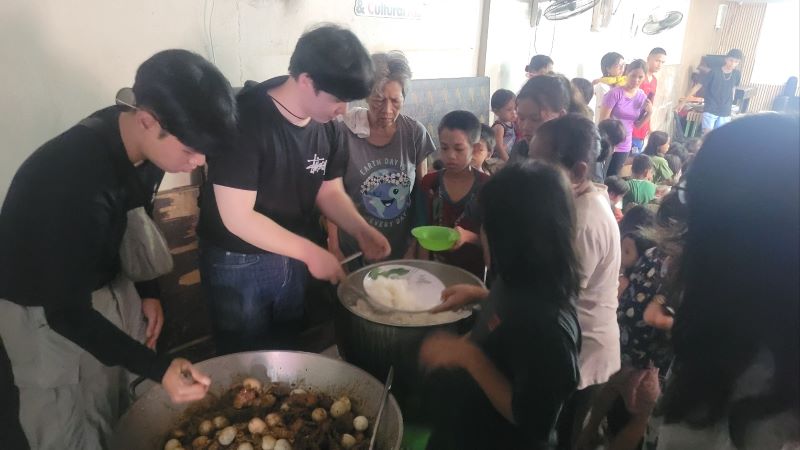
[335,260,483,404]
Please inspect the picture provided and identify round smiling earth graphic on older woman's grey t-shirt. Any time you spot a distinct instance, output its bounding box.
[361,169,411,220]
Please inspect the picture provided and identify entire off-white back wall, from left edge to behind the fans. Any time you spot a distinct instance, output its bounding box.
[0,0,776,200]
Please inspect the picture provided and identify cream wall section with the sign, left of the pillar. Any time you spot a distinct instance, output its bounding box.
[0,0,483,201]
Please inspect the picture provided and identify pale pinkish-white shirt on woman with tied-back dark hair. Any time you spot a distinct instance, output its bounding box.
[575,182,621,389]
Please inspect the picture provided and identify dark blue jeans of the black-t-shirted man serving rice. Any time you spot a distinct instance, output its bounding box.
[200,243,308,354]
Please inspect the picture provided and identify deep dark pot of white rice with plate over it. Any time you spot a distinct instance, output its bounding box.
[335,260,483,402]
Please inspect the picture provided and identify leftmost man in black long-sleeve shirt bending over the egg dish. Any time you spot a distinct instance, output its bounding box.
[0,50,236,449]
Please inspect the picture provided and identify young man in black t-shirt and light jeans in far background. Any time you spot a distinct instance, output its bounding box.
[687,48,742,134]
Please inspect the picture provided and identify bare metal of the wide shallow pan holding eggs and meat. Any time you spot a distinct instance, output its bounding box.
[109,351,403,450]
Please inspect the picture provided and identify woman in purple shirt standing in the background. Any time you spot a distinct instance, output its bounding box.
[598,59,653,176]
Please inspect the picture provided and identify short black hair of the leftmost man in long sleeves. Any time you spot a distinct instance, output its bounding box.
[133,49,237,155]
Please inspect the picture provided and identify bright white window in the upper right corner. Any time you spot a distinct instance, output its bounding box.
[745,0,800,85]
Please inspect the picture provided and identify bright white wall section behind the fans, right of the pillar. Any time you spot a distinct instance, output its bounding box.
[486,0,692,129]
